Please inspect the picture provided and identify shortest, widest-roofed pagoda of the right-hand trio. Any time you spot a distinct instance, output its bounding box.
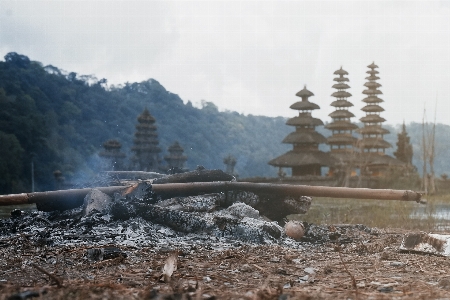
[269,86,333,176]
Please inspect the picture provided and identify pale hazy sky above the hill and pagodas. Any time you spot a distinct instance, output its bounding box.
[0,0,450,125]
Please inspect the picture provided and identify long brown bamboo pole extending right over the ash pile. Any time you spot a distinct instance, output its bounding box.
[152,181,422,202]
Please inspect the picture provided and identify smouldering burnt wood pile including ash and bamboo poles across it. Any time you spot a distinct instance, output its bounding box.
[0,168,420,245]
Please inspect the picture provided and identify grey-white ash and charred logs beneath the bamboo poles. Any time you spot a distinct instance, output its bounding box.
[0,188,380,253]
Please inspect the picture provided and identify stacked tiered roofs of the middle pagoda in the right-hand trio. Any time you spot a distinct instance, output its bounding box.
[325,67,358,156]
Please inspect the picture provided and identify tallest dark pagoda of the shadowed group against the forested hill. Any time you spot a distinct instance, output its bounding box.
[131,108,161,171]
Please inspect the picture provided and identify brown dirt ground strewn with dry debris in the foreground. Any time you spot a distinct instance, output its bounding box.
[0,228,450,300]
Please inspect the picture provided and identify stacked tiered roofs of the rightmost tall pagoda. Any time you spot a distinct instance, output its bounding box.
[357,63,392,153]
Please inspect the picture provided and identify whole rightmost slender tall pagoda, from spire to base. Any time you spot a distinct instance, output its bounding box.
[356,63,403,176]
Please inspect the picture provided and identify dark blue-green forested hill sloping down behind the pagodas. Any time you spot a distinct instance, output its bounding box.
[0,53,450,194]
